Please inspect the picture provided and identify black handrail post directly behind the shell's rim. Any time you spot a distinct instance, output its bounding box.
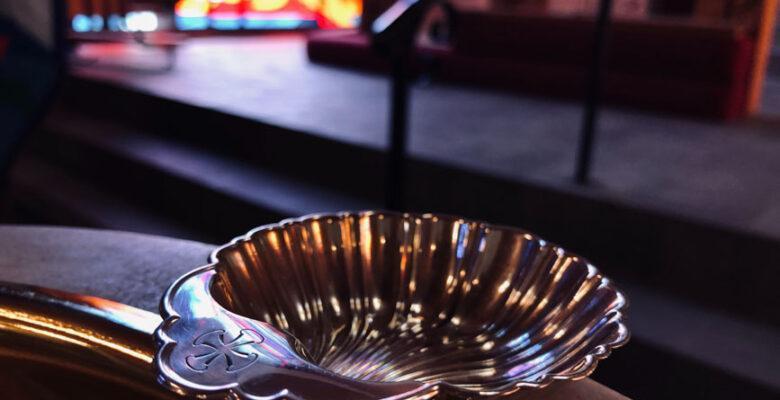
[385,55,409,211]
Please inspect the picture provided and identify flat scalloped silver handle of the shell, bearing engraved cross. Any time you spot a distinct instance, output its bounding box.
[155,266,432,400]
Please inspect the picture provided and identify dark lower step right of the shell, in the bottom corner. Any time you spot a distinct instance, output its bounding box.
[595,284,780,400]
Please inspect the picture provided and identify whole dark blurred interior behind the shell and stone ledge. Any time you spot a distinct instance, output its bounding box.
[0,0,780,399]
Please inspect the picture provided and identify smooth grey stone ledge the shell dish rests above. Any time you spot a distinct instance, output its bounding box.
[0,225,626,400]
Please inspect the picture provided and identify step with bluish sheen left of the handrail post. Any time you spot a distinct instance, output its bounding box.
[33,108,376,240]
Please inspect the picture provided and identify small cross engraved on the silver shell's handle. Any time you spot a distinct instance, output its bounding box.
[185,329,264,372]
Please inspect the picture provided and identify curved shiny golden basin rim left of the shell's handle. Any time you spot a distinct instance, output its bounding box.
[0,282,178,400]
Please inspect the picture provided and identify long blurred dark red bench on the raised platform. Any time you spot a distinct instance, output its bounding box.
[307,3,755,119]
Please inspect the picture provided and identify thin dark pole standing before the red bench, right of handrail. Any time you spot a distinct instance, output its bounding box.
[574,0,612,184]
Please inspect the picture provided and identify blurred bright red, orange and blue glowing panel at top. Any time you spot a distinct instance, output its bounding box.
[175,0,363,30]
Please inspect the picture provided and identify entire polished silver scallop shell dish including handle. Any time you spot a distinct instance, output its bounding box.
[155,212,629,400]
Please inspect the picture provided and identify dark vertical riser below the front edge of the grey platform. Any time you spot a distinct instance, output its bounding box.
[53,77,780,326]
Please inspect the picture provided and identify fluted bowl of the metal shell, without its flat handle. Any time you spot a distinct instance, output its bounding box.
[207,212,628,394]
